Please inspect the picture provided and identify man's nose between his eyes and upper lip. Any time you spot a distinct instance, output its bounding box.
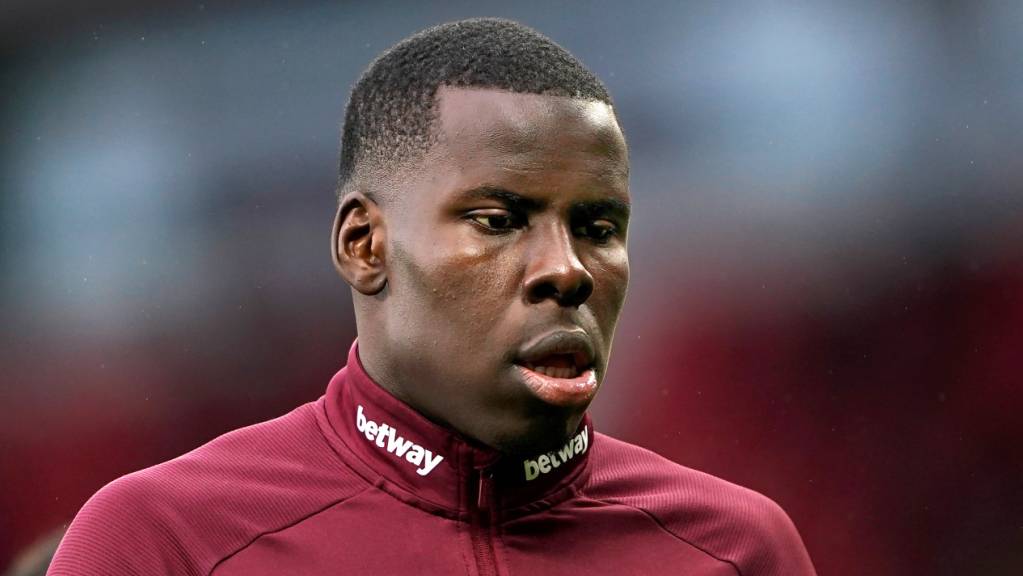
[525,223,593,308]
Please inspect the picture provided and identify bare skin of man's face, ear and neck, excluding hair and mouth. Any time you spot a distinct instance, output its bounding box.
[331,87,629,453]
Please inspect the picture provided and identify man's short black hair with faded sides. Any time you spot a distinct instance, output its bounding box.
[338,18,612,197]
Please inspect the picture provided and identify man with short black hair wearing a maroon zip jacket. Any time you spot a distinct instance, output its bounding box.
[50,19,813,576]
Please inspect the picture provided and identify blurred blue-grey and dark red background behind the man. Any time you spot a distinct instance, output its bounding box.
[0,0,1023,575]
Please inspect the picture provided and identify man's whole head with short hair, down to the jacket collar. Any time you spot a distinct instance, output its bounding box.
[331,19,629,452]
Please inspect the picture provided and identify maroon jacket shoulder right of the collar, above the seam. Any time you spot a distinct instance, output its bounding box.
[584,435,813,576]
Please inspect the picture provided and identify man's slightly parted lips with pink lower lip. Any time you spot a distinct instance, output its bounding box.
[516,329,597,406]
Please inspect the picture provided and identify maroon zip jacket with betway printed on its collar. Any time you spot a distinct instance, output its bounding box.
[48,346,814,576]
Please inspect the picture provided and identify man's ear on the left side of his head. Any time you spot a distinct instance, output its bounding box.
[330,191,387,296]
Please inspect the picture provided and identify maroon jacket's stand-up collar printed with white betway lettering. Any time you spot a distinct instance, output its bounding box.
[323,342,593,515]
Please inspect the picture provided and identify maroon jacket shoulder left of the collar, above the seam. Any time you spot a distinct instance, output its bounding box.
[50,403,365,574]
